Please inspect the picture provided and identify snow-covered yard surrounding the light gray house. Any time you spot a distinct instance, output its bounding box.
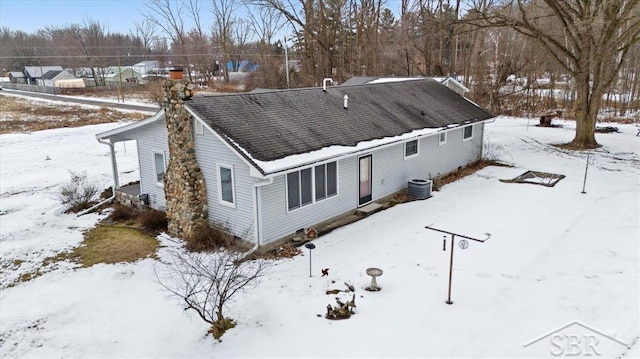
[0,117,640,358]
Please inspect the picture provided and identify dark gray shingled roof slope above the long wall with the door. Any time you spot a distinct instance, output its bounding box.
[186,79,494,161]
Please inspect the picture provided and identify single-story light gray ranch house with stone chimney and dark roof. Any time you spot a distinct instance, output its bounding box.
[96,79,494,247]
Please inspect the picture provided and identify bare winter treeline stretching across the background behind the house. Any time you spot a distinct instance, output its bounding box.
[0,0,640,113]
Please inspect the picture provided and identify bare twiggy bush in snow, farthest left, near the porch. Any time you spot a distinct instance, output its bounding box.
[58,171,100,213]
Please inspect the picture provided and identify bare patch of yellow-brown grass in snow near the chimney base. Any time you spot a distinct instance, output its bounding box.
[60,225,159,268]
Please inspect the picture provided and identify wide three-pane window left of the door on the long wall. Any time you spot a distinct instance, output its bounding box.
[287,162,338,210]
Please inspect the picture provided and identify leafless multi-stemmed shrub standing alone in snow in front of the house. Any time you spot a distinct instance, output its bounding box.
[156,251,268,339]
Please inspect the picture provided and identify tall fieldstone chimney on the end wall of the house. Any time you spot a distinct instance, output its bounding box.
[163,80,208,240]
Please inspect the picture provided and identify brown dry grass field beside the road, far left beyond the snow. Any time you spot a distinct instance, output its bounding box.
[0,95,146,134]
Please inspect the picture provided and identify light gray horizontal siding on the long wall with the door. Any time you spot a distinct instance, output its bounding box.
[260,123,483,245]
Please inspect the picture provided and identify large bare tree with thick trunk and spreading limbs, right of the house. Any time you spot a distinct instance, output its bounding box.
[472,0,640,148]
